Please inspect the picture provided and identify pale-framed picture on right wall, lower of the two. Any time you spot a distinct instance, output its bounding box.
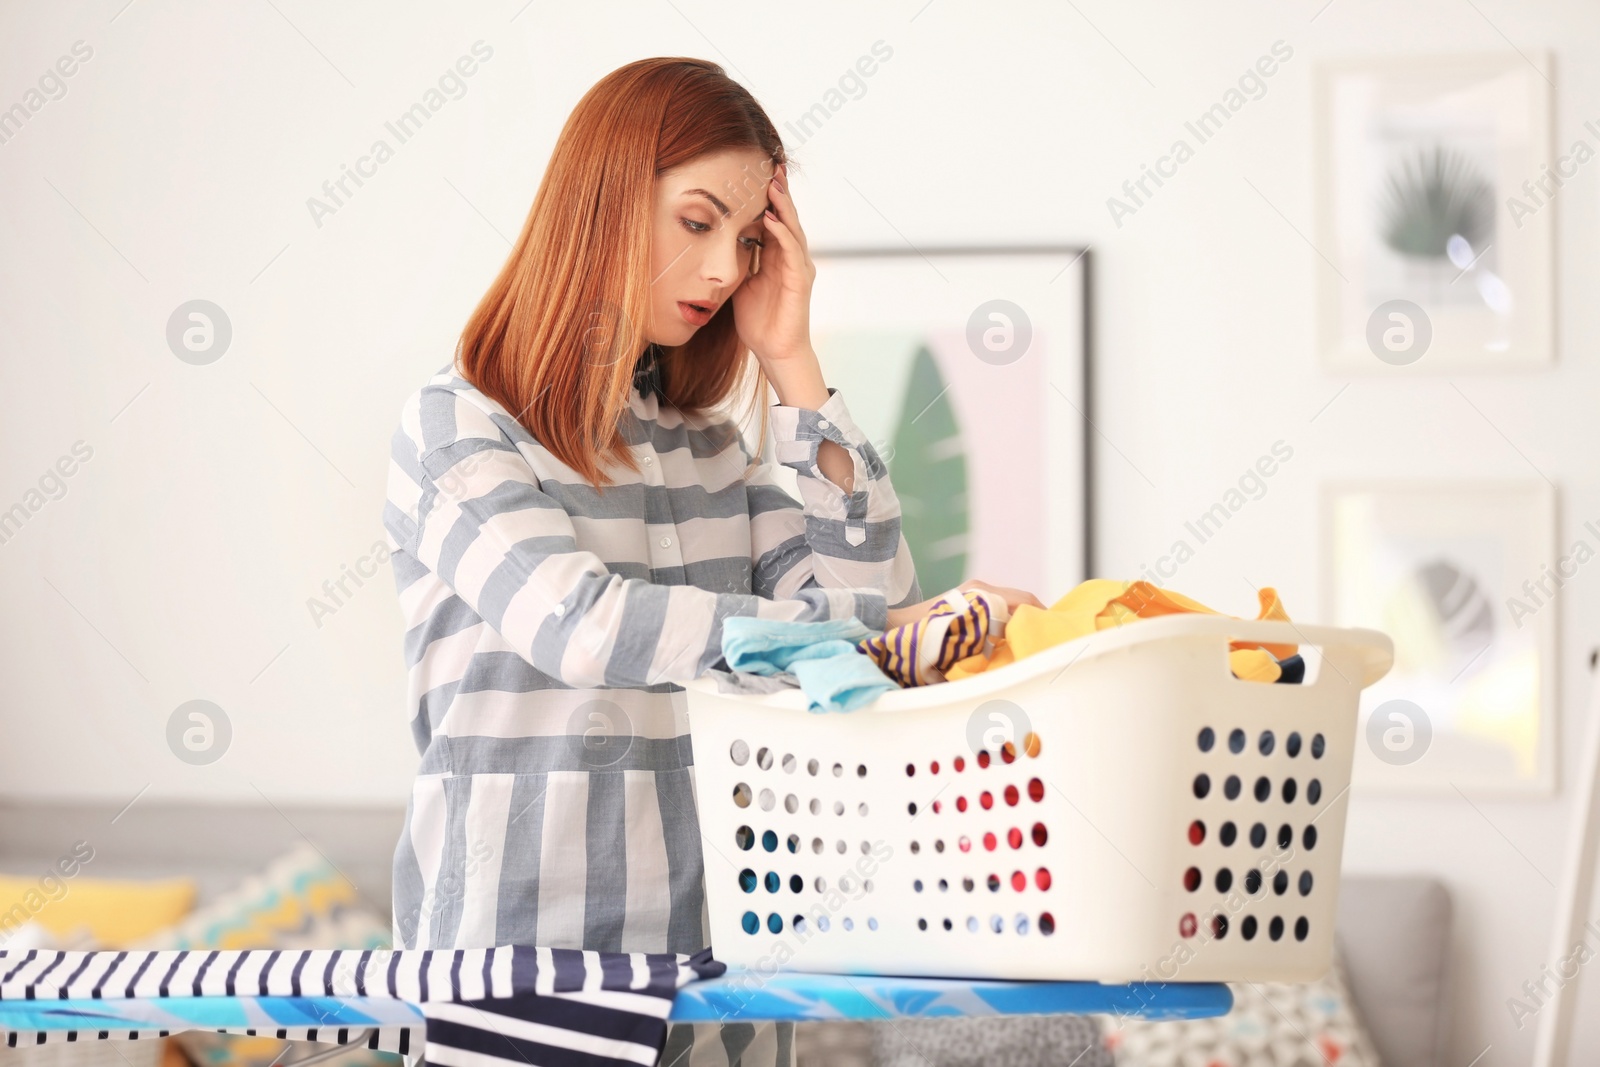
[1322,480,1555,795]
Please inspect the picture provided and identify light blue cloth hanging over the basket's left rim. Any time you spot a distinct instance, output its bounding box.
[722,616,899,712]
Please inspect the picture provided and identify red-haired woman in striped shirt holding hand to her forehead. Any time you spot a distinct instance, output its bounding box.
[384,59,1042,1065]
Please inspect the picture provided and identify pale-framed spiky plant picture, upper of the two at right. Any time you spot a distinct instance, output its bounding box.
[1312,51,1548,373]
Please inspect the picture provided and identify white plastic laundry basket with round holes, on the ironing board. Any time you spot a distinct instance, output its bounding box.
[686,614,1394,982]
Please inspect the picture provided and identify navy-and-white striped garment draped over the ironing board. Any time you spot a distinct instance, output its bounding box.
[0,945,725,1067]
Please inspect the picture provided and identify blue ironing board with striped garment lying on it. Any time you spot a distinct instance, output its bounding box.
[0,945,1232,1064]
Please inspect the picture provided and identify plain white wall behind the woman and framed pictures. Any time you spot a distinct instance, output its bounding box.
[0,0,1600,1067]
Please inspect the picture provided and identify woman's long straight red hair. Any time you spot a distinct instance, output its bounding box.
[456,58,789,486]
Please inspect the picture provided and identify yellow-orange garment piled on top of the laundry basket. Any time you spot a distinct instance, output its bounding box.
[944,577,1299,681]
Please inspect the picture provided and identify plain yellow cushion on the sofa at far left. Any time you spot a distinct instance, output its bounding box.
[0,873,195,949]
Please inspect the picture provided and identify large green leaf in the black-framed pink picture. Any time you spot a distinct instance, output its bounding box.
[888,344,970,595]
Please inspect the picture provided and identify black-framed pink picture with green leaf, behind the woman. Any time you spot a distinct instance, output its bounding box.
[758,248,1093,603]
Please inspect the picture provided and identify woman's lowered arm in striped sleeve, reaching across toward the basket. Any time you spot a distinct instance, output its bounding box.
[384,387,888,688]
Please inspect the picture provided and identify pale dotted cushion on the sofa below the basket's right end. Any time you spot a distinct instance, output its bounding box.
[1102,955,1379,1067]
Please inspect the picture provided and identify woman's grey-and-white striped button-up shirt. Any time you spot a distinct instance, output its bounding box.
[384,366,922,1064]
